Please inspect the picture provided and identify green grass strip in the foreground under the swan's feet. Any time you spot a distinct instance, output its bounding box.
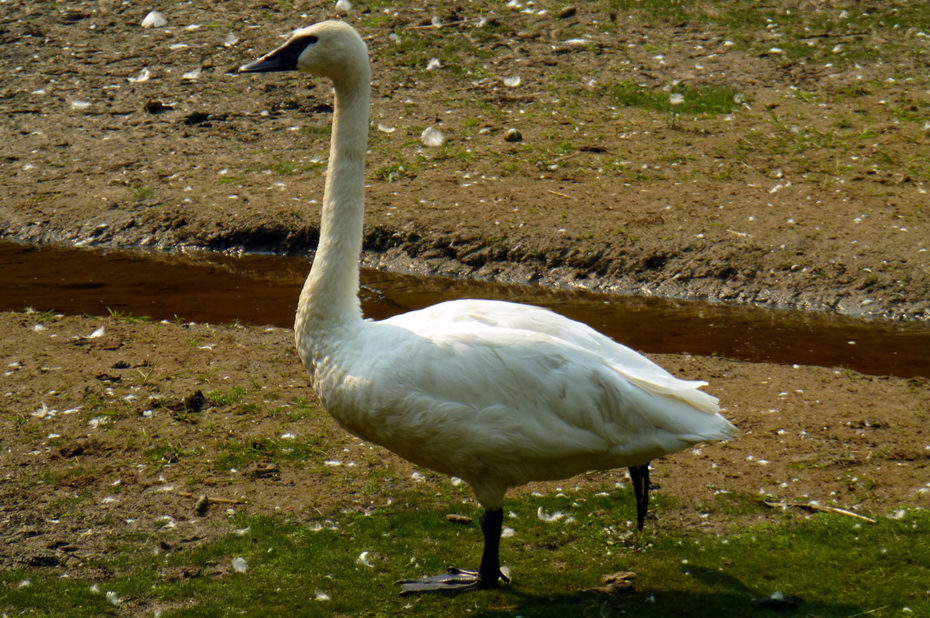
[0,486,930,616]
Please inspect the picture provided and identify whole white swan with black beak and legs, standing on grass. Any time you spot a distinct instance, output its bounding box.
[240,21,734,593]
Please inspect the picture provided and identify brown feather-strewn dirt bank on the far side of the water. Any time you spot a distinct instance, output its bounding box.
[0,0,930,319]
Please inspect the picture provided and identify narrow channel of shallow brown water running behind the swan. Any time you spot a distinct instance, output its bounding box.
[0,242,930,377]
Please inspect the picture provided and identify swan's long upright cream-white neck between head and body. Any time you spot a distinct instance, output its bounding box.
[295,69,371,348]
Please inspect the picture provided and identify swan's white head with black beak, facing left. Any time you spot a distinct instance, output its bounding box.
[239,20,370,84]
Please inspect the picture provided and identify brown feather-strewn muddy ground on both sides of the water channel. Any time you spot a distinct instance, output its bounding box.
[0,0,930,592]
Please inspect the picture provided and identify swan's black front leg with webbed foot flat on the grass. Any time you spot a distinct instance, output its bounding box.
[398,509,510,595]
